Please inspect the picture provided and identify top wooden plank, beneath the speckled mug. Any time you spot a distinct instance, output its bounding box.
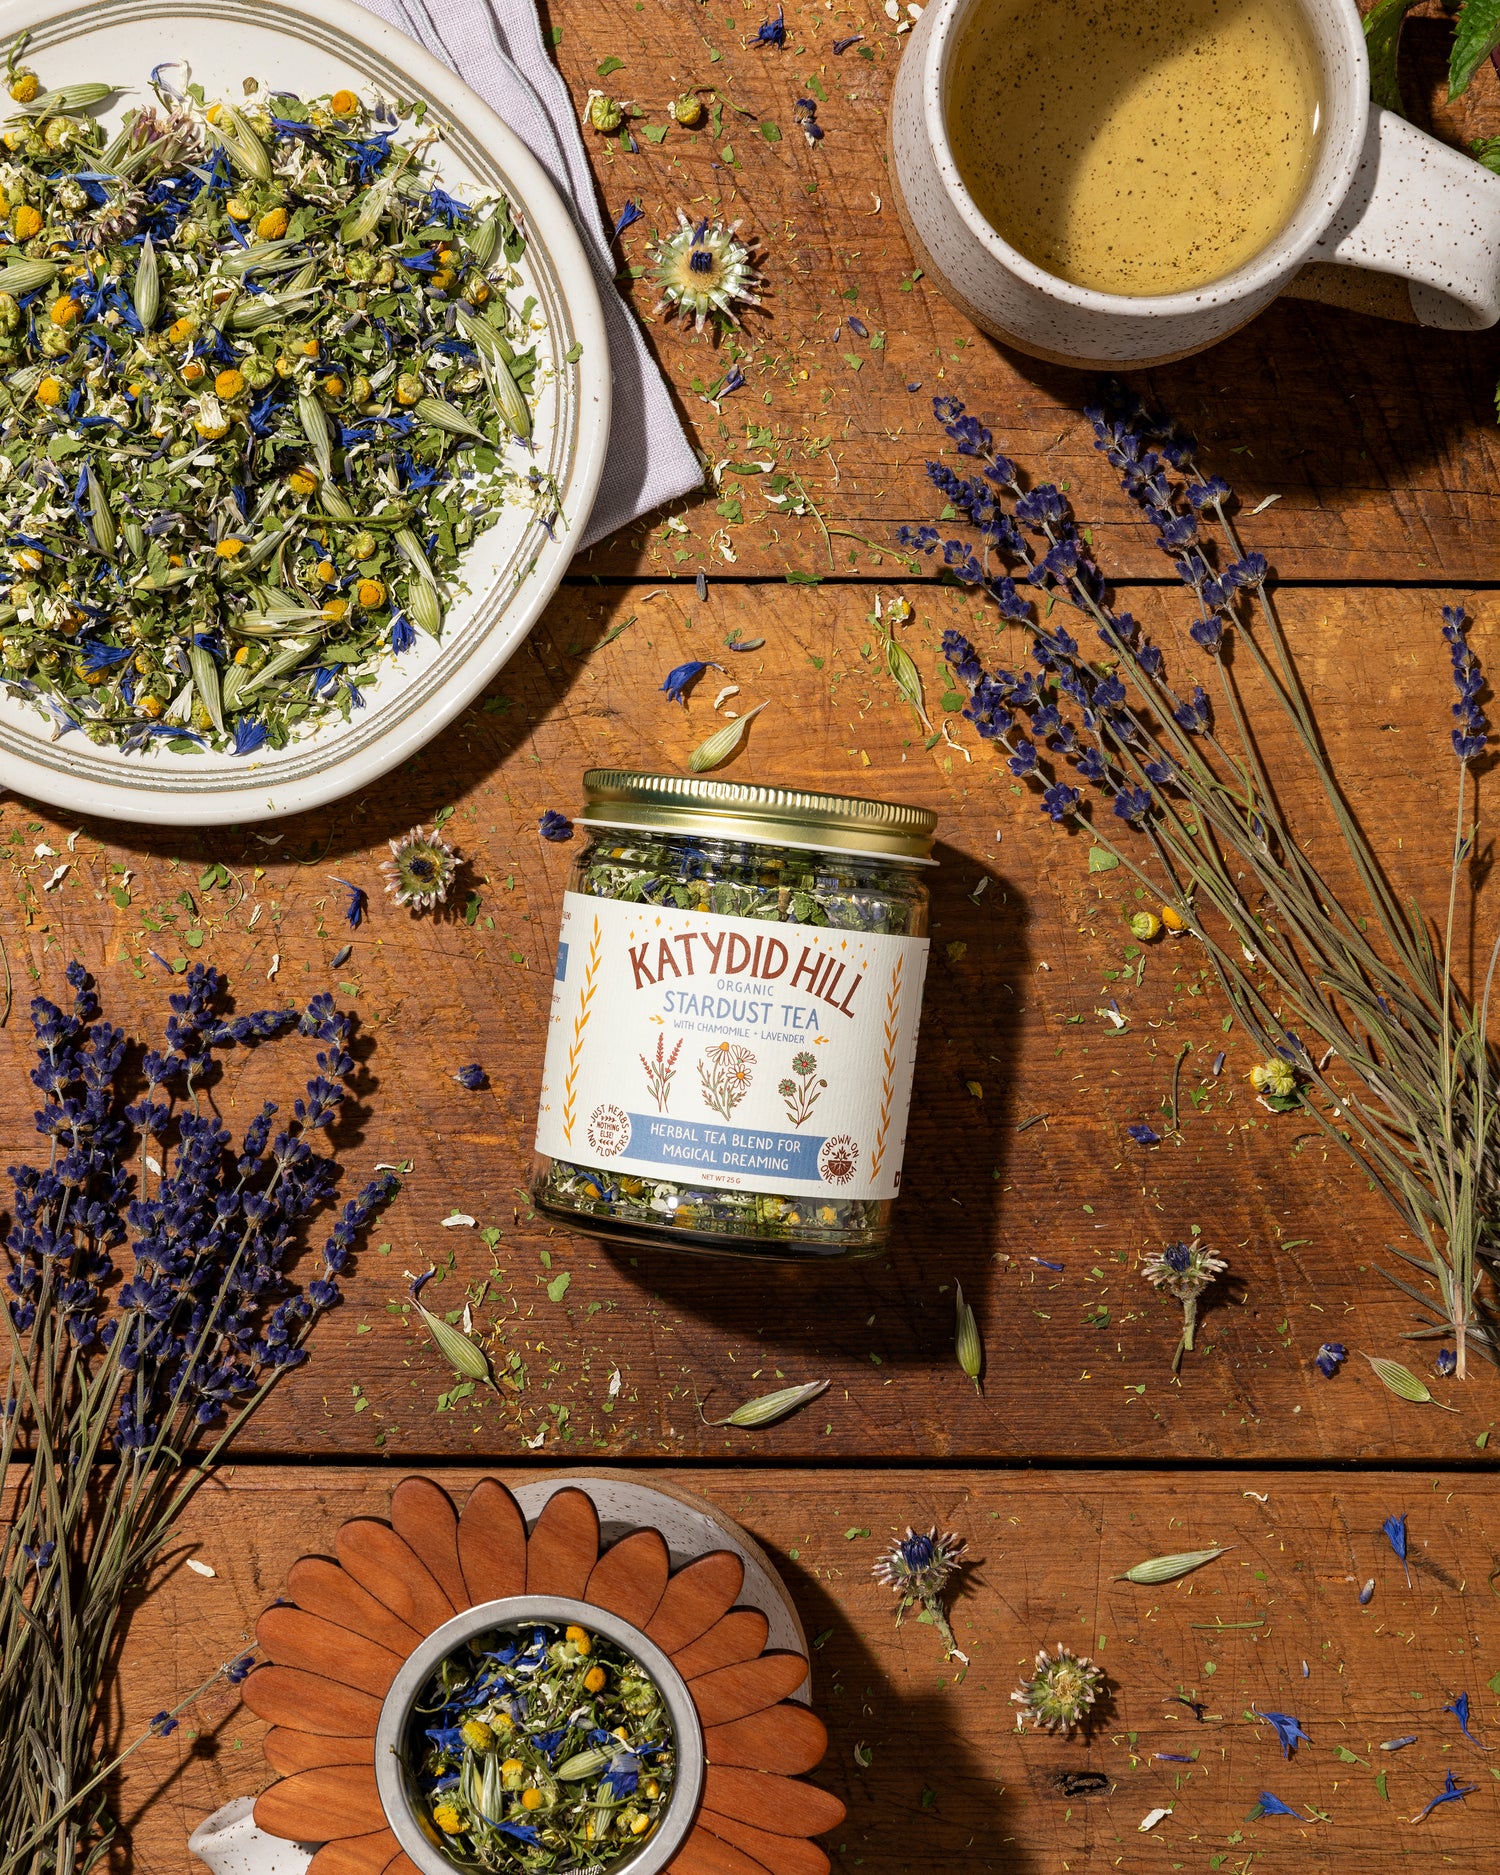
[525,0,1500,581]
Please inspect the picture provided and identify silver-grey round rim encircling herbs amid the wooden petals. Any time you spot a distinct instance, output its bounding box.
[375,1596,705,1875]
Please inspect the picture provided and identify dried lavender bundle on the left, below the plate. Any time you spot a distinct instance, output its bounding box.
[0,964,396,1875]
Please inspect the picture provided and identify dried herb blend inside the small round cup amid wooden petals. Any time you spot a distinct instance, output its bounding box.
[409,1622,675,1869]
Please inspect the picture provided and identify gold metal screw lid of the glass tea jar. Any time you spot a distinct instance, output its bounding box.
[579,769,938,866]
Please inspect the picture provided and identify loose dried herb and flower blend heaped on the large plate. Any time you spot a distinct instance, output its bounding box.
[0,51,555,756]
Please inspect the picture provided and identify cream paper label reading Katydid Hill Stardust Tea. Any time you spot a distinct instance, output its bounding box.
[536,893,928,1200]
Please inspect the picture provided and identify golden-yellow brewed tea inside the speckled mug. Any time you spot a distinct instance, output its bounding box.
[947,0,1322,294]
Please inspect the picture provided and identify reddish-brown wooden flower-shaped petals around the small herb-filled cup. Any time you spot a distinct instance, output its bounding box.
[244,1478,844,1875]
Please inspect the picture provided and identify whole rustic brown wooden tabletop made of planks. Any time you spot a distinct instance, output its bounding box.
[0,0,1500,1875]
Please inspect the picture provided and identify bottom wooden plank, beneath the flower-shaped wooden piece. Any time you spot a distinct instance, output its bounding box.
[108,1470,1500,1875]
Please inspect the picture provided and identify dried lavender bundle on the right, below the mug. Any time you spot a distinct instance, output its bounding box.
[898,386,1500,1378]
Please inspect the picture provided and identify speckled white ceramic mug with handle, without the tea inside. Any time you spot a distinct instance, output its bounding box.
[891,0,1500,366]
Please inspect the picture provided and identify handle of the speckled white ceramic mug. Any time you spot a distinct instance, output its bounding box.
[1290,109,1500,332]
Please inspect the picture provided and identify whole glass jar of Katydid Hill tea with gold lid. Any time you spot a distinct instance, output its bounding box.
[534,769,936,1260]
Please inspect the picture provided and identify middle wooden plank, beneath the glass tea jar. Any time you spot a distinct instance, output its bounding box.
[11,587,1500,1462]
